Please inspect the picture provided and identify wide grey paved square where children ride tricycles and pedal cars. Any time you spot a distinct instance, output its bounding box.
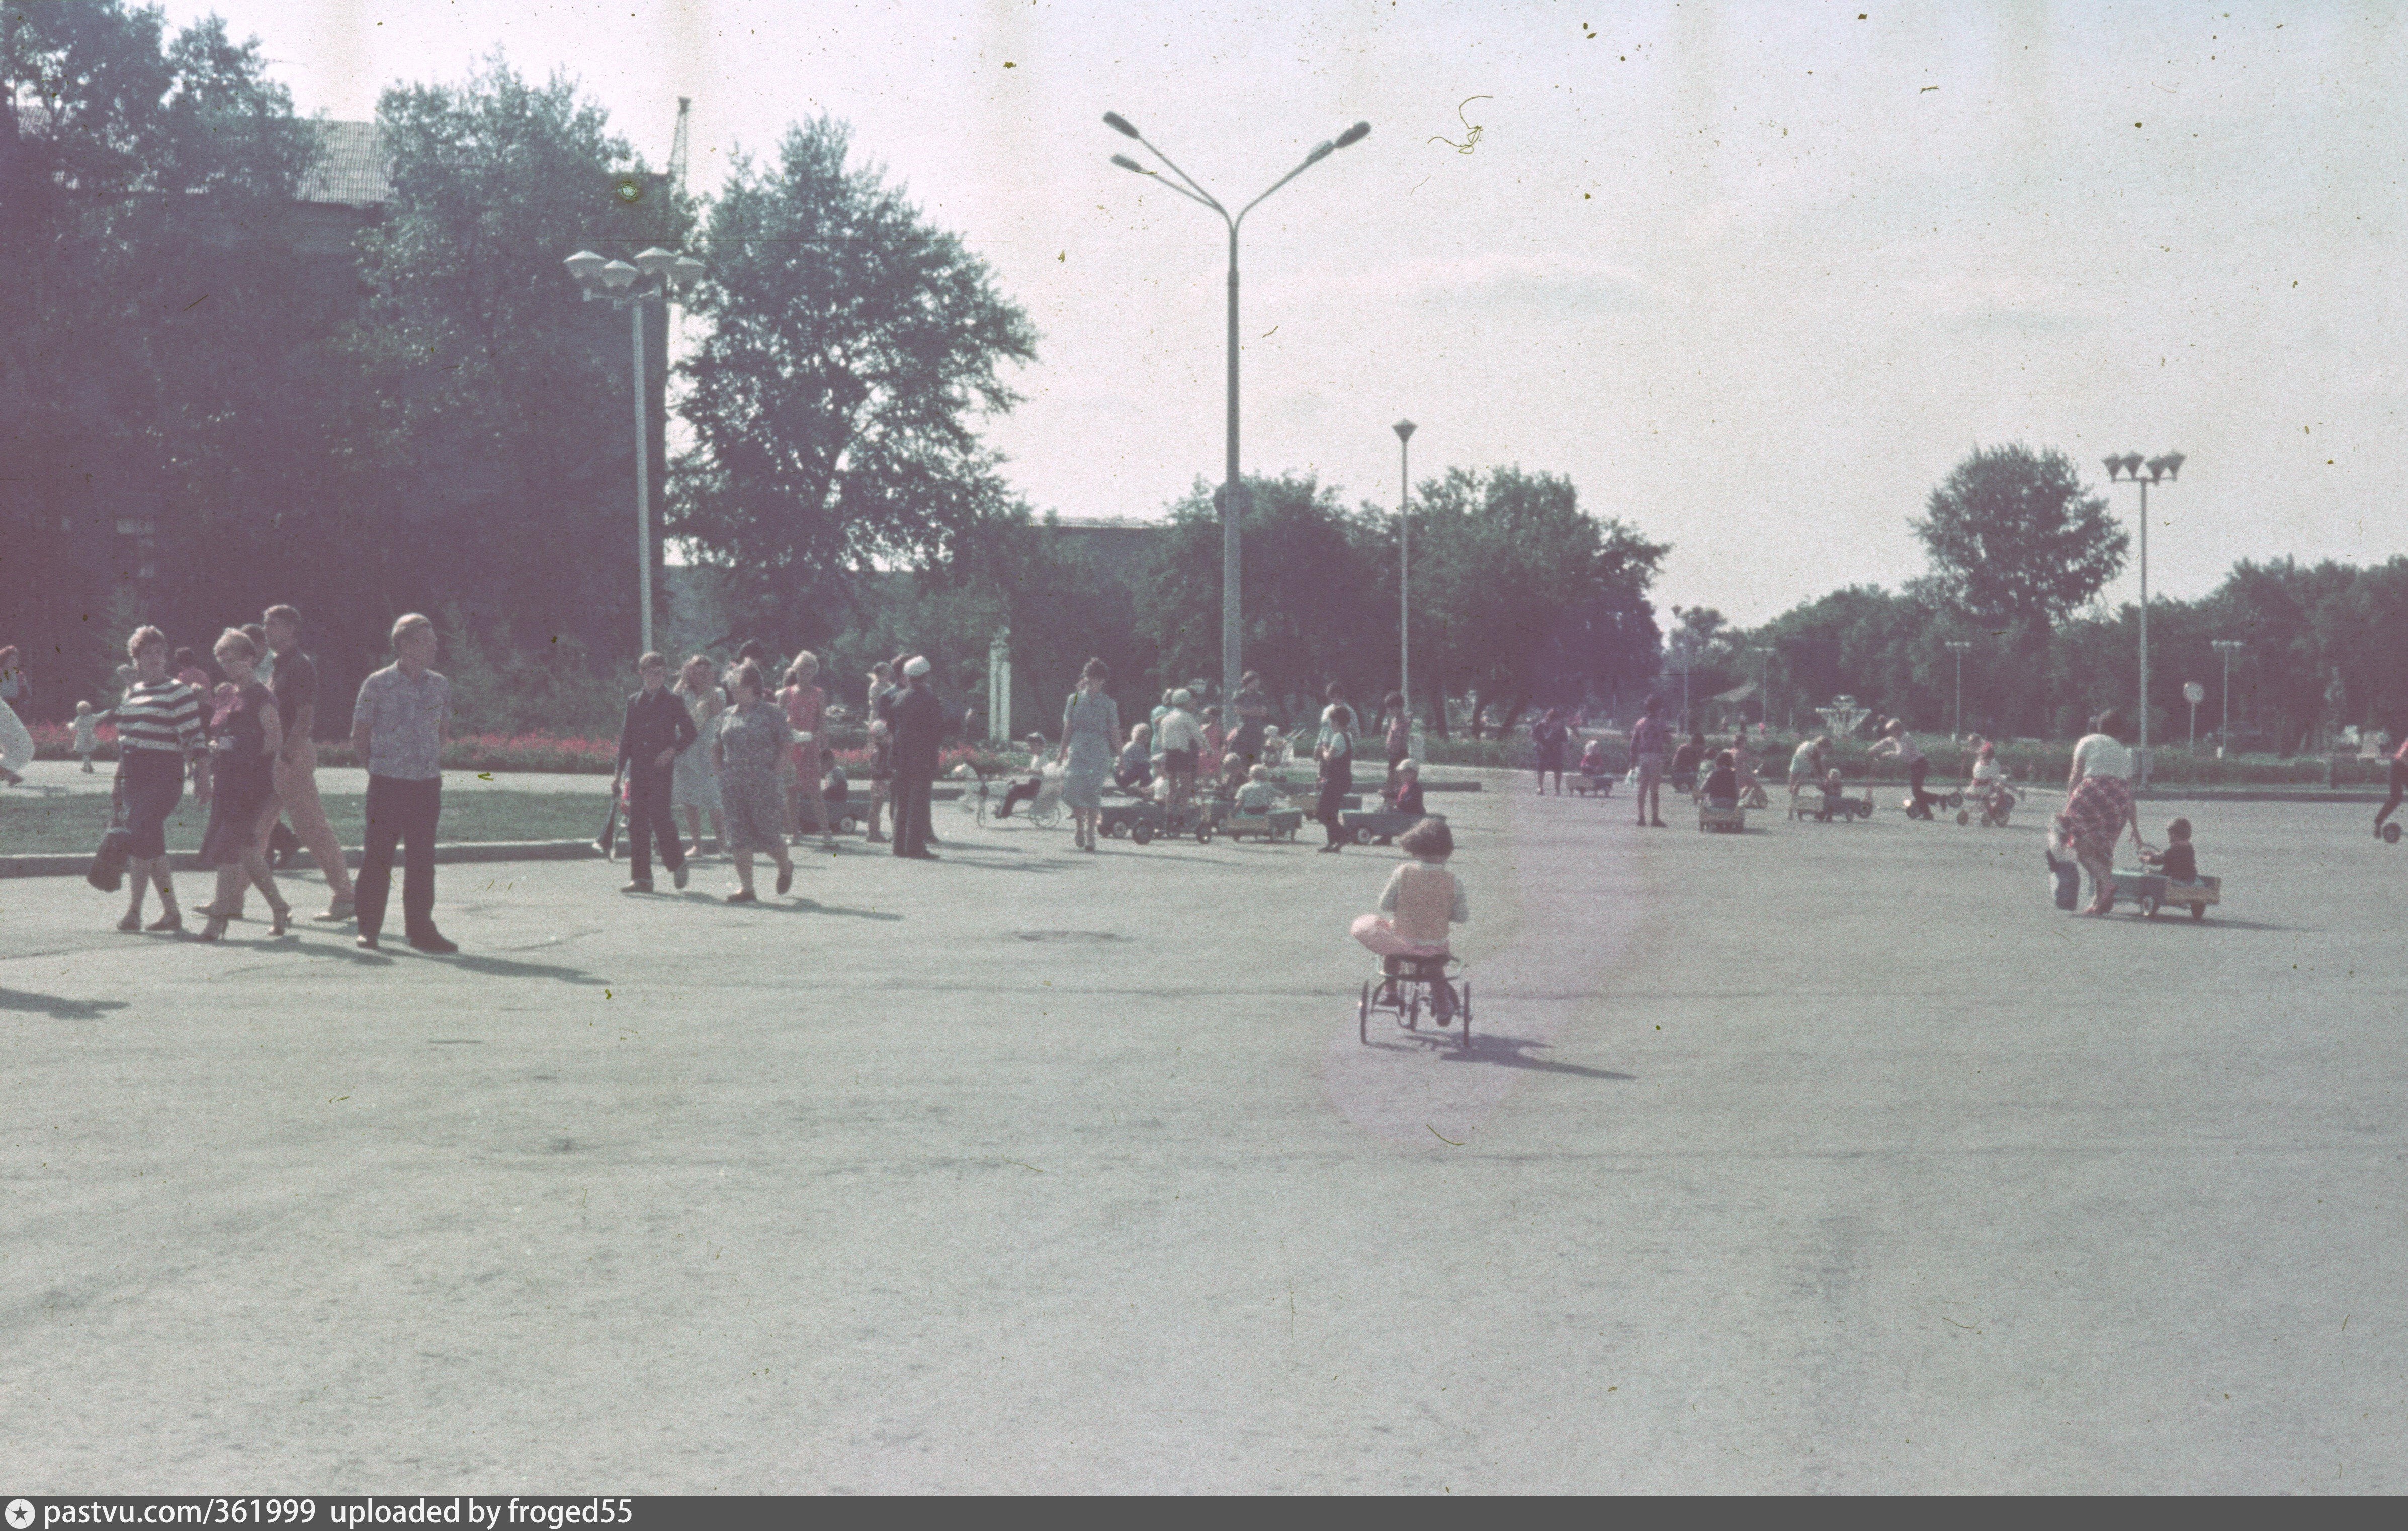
[0,775,2408,1492]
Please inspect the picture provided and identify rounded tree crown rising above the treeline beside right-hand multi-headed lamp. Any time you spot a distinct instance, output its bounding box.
[1907,445,2131,623]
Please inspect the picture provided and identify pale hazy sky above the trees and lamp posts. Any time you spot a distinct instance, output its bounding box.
[168,0,2408,623]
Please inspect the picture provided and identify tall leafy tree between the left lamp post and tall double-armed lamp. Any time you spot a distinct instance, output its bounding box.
[672,118,1036,641]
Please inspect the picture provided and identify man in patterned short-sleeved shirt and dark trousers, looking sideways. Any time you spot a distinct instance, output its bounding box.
[352,611,460,953]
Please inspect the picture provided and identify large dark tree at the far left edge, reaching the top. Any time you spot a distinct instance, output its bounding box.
[0,0,330,703]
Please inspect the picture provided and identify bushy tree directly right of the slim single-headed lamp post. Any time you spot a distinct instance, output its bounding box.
[1414,467,1671,727]
